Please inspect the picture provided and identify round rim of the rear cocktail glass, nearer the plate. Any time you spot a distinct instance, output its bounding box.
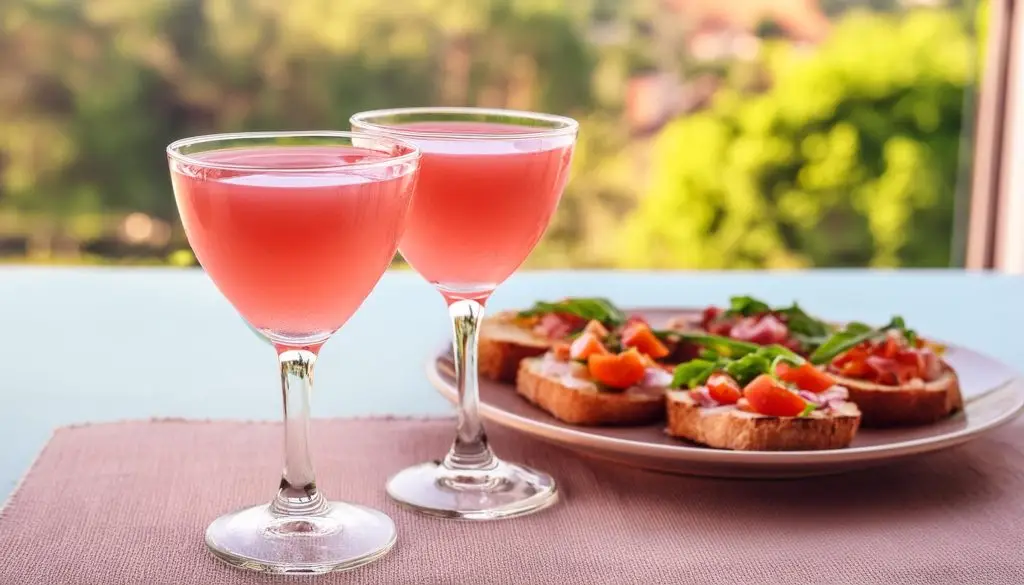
[348,106,580,140]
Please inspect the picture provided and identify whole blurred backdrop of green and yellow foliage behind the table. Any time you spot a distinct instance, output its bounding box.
[0,0,978,268]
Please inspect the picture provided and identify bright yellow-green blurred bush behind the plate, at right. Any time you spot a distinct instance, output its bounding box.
[618,10,975,268]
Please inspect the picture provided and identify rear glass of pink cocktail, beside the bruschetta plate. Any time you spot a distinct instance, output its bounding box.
[351,108,579,519]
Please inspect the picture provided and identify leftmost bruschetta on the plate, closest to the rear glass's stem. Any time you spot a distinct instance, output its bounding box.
[477,298,626,383]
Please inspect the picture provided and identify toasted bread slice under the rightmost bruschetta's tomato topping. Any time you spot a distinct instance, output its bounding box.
[833,364,964,427]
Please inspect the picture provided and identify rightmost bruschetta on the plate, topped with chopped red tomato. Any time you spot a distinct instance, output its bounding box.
[811,318,964,427]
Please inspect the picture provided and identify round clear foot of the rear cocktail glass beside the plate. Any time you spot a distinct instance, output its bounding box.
[387,461,558,520]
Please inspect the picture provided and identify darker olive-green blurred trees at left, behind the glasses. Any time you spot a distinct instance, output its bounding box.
[0,0,595,256]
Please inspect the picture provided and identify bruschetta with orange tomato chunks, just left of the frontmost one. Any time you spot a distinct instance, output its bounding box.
[516,321,672,426]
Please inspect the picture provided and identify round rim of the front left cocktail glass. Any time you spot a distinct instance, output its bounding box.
[166,130,421,173]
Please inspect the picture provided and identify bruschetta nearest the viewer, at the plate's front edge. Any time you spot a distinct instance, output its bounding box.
[666,336,861,451]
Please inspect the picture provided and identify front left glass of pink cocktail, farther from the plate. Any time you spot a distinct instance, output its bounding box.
[167,132,420,573]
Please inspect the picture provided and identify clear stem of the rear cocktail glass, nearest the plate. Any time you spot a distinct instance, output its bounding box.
[443,299,497,471]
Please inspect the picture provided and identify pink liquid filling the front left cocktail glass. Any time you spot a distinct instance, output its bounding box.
[171,147,415,339]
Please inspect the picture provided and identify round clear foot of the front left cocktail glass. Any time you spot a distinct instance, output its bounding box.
[206,502,396,574]
